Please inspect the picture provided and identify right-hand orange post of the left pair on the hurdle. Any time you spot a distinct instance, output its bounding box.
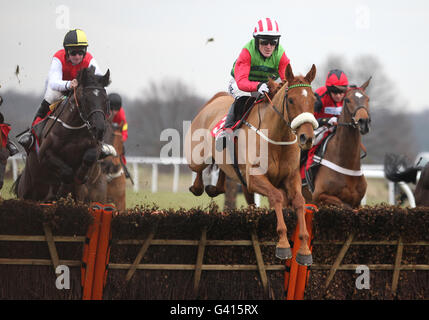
[92,206,115,300]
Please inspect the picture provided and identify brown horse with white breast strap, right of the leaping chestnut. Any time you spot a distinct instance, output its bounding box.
[303,78,371,208]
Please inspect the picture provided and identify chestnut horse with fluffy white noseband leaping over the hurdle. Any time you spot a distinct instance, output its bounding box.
[185,64,317,265]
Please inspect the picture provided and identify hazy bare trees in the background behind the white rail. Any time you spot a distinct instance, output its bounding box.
[0,55,429,164]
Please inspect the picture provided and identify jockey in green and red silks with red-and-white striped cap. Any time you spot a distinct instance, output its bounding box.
[216,18,290,151]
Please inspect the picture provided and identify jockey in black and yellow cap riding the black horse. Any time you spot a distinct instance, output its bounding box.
[18,29,111,156]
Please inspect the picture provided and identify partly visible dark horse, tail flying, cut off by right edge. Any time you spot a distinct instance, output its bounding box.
[384,154,429,207]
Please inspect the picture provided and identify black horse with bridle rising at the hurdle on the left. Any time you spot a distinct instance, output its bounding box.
[14,67,110,201]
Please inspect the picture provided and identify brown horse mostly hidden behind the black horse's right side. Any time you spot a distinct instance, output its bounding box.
[102,119,126,212]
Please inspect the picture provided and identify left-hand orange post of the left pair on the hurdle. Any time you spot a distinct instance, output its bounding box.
[82,203,103,300]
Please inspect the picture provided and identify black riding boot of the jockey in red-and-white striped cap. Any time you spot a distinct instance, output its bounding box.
[215,96,250,152]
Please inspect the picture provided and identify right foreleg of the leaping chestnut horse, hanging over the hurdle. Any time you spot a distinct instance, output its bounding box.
[285,173,313,266]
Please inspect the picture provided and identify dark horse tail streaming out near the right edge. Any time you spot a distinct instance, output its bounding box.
[384,153,421,184]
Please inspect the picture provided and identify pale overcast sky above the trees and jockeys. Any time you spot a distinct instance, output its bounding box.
[0,0,429,111]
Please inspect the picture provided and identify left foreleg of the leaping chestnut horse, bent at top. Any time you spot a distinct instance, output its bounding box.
[247,175,292,259]
